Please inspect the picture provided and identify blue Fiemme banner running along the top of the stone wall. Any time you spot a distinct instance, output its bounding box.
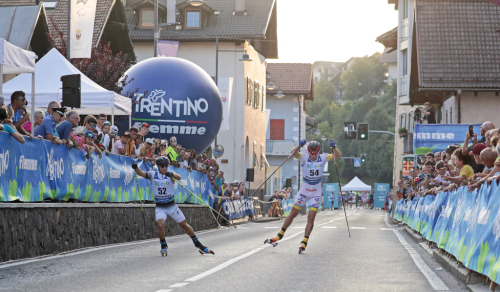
[0,132,214,206]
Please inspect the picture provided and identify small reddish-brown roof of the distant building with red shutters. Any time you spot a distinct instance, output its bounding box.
[266,63,314,100]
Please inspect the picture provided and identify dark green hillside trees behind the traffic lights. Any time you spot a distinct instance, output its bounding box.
[306,55,396,183]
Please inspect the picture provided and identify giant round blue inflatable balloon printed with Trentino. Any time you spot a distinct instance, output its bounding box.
[122,57,222,154]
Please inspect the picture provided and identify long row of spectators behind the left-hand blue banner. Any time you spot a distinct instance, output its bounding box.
[0,91,228,187]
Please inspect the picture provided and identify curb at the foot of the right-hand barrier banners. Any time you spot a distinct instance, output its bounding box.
[394,221,489,292]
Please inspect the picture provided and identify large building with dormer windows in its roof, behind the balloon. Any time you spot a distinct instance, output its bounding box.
[125,0,278,196]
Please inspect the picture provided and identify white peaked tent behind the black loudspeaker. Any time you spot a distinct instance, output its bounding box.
[4,49,132,123]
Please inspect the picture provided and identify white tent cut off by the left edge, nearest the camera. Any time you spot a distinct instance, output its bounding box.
[0,38,37,132]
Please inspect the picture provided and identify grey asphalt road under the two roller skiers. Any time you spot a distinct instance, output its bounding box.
[0,209,468,292]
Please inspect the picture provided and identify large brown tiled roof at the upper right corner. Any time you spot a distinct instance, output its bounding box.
[411,0,500,89]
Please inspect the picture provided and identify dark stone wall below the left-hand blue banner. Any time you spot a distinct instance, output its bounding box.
[0,203,217,262]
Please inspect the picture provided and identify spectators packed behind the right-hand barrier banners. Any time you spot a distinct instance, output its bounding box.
[397,122,500,200]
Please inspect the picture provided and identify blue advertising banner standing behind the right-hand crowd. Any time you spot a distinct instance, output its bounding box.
[413,124,482,154]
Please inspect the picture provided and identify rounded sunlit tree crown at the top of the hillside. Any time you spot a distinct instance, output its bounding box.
[341,53,387,100]
